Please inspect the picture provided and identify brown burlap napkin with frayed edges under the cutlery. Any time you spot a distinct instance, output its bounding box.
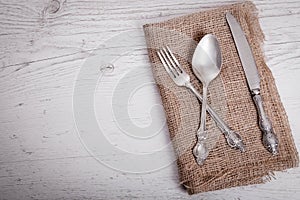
[144,2,299,194]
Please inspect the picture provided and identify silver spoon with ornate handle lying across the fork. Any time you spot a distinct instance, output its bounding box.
[192,34,222,165]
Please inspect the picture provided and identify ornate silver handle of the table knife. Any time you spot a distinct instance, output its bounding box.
[252,89,278,155]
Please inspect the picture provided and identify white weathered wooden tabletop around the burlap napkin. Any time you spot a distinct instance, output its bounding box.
[0,0,300,200]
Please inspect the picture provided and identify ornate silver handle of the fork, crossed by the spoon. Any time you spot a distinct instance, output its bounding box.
[185,83,245,152]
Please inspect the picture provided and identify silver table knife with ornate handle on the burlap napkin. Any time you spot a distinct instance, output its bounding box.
[226,12,278,155]
